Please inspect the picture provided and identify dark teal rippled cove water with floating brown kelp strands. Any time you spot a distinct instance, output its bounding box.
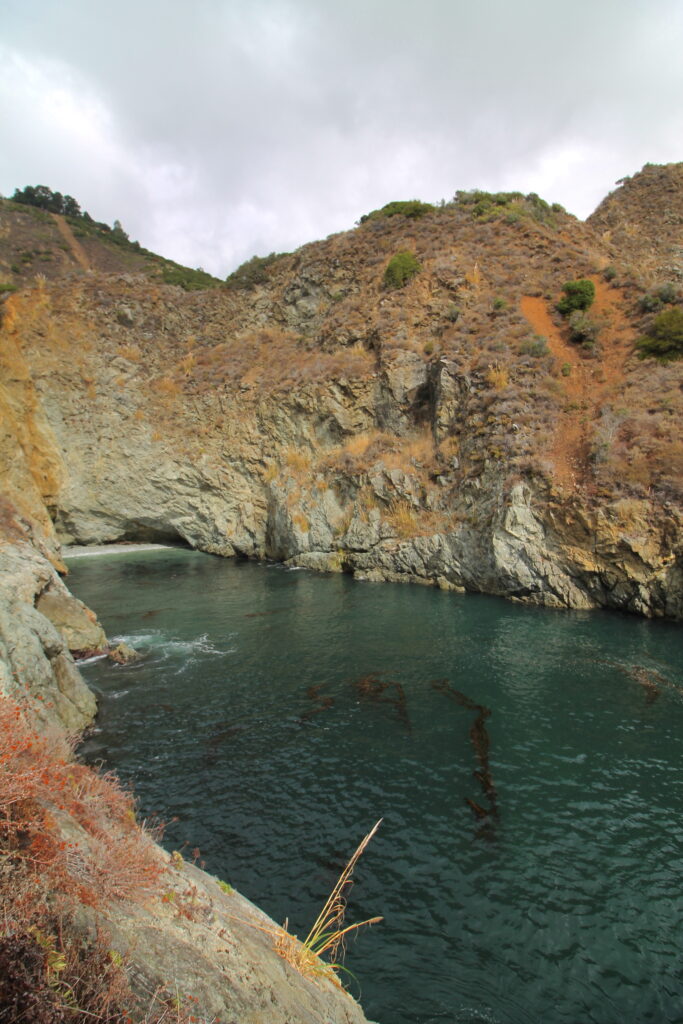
[71,550,683,1024]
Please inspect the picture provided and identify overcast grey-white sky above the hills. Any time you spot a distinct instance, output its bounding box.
[0,0,683,276]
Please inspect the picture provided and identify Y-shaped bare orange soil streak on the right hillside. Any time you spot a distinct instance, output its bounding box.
[519,278,635,492]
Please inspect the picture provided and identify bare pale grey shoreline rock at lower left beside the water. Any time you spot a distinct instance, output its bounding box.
[0,541,374,1024]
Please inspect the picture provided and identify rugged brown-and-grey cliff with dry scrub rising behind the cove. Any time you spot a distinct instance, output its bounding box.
[3,169,683,615]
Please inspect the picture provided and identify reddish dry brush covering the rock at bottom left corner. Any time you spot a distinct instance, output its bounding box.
[0,696,219,1024]
